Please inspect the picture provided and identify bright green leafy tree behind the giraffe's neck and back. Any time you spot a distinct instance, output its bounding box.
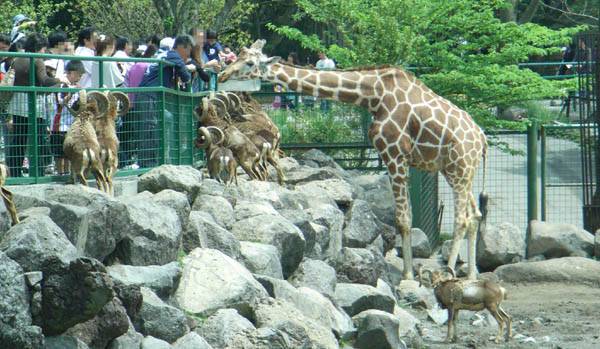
[270,0,582,124]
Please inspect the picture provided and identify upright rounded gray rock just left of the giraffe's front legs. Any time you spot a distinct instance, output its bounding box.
[342,199,379,248]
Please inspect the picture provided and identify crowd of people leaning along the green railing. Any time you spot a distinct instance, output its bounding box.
[0,14,235,177]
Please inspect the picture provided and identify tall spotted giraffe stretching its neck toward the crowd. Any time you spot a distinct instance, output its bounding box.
[218,40,487,280]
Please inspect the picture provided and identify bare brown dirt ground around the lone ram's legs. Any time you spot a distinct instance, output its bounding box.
[407,283,600,349]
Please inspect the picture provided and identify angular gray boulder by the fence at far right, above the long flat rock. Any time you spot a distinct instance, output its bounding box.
[527,221,594,258]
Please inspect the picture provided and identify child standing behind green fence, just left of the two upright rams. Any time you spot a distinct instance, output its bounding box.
[50,60,85,175]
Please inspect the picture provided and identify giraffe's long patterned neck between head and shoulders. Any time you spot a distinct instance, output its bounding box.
[264,63,408,113]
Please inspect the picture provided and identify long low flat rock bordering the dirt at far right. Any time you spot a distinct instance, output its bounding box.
[494,257,600,286]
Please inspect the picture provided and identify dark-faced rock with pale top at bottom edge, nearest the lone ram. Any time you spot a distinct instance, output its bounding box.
[352,310,402,349]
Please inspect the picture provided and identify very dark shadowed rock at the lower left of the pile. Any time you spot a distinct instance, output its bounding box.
[39,257,114,336]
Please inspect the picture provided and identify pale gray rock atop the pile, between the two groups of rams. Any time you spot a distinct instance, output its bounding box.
[138,165,203,203]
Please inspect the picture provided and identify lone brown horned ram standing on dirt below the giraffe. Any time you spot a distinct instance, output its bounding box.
[419,267,511,343]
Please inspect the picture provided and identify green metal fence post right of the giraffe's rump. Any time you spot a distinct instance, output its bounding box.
[527,119,539,250]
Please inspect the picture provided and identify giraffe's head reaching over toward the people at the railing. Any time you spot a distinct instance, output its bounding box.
[219,40,281,82]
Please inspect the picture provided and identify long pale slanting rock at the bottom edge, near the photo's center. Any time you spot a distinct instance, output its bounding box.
[253,298,339,349]
